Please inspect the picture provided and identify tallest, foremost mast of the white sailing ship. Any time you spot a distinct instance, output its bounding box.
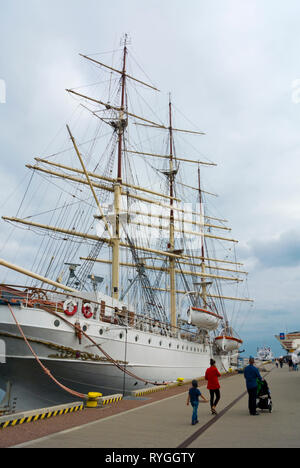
[112,34,127,299]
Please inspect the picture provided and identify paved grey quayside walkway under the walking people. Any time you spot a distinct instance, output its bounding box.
[7,366,300,449]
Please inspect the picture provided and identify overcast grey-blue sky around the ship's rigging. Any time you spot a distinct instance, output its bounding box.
[0,0,300,355]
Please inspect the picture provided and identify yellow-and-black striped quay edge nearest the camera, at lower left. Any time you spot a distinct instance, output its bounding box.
[0,402,84,429]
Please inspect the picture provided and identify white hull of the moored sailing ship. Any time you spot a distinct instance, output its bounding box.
[0,306,232,410]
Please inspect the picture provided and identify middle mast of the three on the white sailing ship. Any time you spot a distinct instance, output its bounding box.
[169,95,177,327]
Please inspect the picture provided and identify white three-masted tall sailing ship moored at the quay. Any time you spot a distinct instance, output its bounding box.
[0,37,251,409]
